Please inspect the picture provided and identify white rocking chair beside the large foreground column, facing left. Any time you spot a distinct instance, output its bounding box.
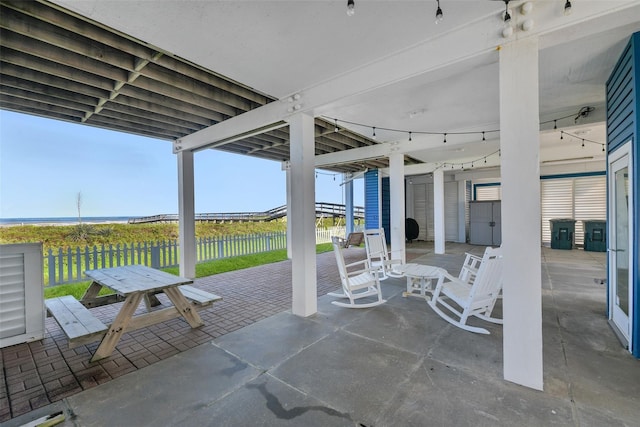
[428,248,502,334]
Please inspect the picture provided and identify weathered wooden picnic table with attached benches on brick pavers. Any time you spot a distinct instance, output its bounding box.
[45,265,222,362]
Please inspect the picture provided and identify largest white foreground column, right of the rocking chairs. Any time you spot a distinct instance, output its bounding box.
[500,38,543,390]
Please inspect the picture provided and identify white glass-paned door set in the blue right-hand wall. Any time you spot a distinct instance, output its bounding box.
[608,143,633,348]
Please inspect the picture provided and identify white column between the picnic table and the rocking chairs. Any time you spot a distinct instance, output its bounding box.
[288,114,318,317]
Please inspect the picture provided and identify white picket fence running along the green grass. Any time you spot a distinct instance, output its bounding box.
[44,227,345,286]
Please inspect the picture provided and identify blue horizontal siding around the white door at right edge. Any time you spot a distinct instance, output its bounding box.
[607,33,640,358]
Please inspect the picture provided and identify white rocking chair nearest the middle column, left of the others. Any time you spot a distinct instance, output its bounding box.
[327,237,387,308]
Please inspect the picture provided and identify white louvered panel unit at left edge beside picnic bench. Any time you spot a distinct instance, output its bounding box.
[0,243,45,348]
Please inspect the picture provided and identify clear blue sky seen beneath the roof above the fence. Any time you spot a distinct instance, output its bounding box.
[0,110,364,218]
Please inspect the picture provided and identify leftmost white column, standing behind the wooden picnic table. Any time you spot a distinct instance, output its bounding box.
[177,151,196,279]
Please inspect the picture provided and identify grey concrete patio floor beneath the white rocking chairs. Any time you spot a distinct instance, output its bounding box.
[3,243,640,427]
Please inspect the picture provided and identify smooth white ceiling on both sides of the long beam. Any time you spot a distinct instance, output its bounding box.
[56,0,640,172]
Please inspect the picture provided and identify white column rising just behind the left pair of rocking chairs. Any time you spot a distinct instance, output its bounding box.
[389,153,407,263]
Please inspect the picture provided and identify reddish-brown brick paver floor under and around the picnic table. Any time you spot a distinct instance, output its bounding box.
[0,248,404,422]
